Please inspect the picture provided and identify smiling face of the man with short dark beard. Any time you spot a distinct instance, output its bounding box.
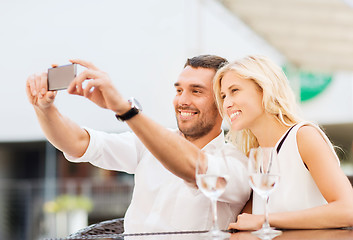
[173,66,222,139]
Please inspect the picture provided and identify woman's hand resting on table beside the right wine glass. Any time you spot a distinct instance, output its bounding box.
[228,213,265,230]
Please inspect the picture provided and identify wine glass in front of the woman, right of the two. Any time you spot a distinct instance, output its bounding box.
[248,147,281,239]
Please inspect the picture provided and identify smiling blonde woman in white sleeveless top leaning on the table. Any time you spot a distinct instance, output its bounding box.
[214,56,353,230]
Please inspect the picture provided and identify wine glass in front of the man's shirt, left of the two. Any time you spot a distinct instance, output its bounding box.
[195,150,230,239]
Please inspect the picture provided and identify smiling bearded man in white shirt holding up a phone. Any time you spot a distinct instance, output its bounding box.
[27,55,250,233]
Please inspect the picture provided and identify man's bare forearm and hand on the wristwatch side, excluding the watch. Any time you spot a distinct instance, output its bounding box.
[64,60,200,183]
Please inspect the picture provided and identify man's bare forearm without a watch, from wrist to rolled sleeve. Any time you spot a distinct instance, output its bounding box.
[34,105,89,157]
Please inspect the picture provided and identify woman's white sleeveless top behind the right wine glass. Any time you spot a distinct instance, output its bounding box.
[253,122,339,214]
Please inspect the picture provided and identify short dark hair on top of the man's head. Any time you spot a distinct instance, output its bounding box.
[184,55,228,71]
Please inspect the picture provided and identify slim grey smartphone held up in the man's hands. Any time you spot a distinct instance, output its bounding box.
[48,63,77,91]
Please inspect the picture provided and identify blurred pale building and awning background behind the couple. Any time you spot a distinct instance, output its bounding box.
[0,0,353,240]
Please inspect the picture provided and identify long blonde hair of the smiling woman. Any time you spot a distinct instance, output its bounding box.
[213,56,301,156]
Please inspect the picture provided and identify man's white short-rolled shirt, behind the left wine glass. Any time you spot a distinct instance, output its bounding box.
[65,129,251,233]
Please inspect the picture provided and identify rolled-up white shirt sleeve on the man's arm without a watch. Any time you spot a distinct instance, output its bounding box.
[64,128,146,174]
